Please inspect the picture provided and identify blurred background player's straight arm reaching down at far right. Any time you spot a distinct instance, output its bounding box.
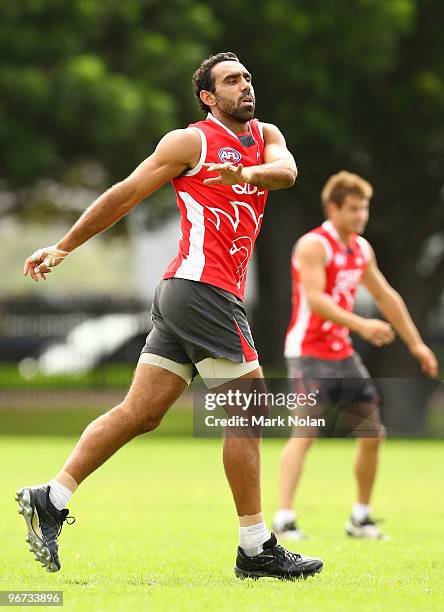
[362,245,438,378]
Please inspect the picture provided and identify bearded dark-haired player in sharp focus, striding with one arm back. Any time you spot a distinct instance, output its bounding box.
[17,53,322,579]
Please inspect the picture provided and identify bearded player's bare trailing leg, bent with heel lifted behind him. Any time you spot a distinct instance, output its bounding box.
[61,364,186,487]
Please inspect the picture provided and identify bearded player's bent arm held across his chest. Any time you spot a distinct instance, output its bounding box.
[204,123,298,191]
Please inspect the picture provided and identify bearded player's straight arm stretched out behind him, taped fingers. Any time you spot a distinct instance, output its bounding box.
[23,129,201,281]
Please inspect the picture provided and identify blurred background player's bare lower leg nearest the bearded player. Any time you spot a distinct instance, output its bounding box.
[279,438,313,510]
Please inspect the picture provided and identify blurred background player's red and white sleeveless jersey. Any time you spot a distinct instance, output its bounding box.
[285,221,370,359]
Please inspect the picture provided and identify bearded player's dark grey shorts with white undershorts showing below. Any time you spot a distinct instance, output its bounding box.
[139,278,259,387]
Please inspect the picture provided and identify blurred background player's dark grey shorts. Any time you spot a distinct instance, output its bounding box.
[287,353,384,437]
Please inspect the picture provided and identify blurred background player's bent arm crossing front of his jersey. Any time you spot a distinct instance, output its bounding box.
[293,239,393,346]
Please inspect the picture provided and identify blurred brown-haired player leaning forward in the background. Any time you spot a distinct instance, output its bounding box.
[273,171,437,539]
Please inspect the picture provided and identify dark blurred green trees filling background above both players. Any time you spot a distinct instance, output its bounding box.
[0,0,444,375]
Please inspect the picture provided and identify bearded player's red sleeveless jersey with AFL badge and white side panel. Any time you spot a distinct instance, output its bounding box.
[164,113,267,300]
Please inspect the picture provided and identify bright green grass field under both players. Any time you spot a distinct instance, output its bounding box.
[0,428,444,612]
